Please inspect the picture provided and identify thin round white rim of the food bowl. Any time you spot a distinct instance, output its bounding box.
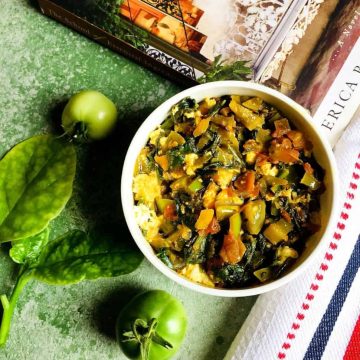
[121,80,339,297]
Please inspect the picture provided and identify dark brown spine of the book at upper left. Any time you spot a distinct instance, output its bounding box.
[38,0,197,87]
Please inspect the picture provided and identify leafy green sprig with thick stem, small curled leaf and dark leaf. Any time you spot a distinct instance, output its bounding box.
[0,230,142,346]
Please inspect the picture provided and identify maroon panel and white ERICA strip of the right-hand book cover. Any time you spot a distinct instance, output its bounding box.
[290,0,360,146]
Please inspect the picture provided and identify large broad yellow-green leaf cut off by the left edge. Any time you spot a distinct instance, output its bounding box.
[0,135,76,243]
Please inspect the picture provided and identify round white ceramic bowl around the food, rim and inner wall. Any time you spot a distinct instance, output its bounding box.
[121,81,337,297]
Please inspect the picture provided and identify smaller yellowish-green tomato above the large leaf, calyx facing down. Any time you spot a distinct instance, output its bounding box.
[61,90,117,140]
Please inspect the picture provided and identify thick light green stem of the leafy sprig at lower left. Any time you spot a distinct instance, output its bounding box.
[0,272,31,347]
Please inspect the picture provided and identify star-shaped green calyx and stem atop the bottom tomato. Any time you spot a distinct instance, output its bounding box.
[122,318,173,360]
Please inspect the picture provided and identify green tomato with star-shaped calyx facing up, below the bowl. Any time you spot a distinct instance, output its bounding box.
[116,290,187,360]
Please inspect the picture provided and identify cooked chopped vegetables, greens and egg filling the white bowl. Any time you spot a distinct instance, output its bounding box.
[133,94,324,288]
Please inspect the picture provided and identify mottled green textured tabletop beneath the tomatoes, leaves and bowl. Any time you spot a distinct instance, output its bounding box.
[0,0,255,360]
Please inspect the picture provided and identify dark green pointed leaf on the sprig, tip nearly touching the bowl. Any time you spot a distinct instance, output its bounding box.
[30,230,143,285]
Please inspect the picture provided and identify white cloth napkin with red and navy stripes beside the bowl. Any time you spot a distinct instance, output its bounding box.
[224,112,360,360]
